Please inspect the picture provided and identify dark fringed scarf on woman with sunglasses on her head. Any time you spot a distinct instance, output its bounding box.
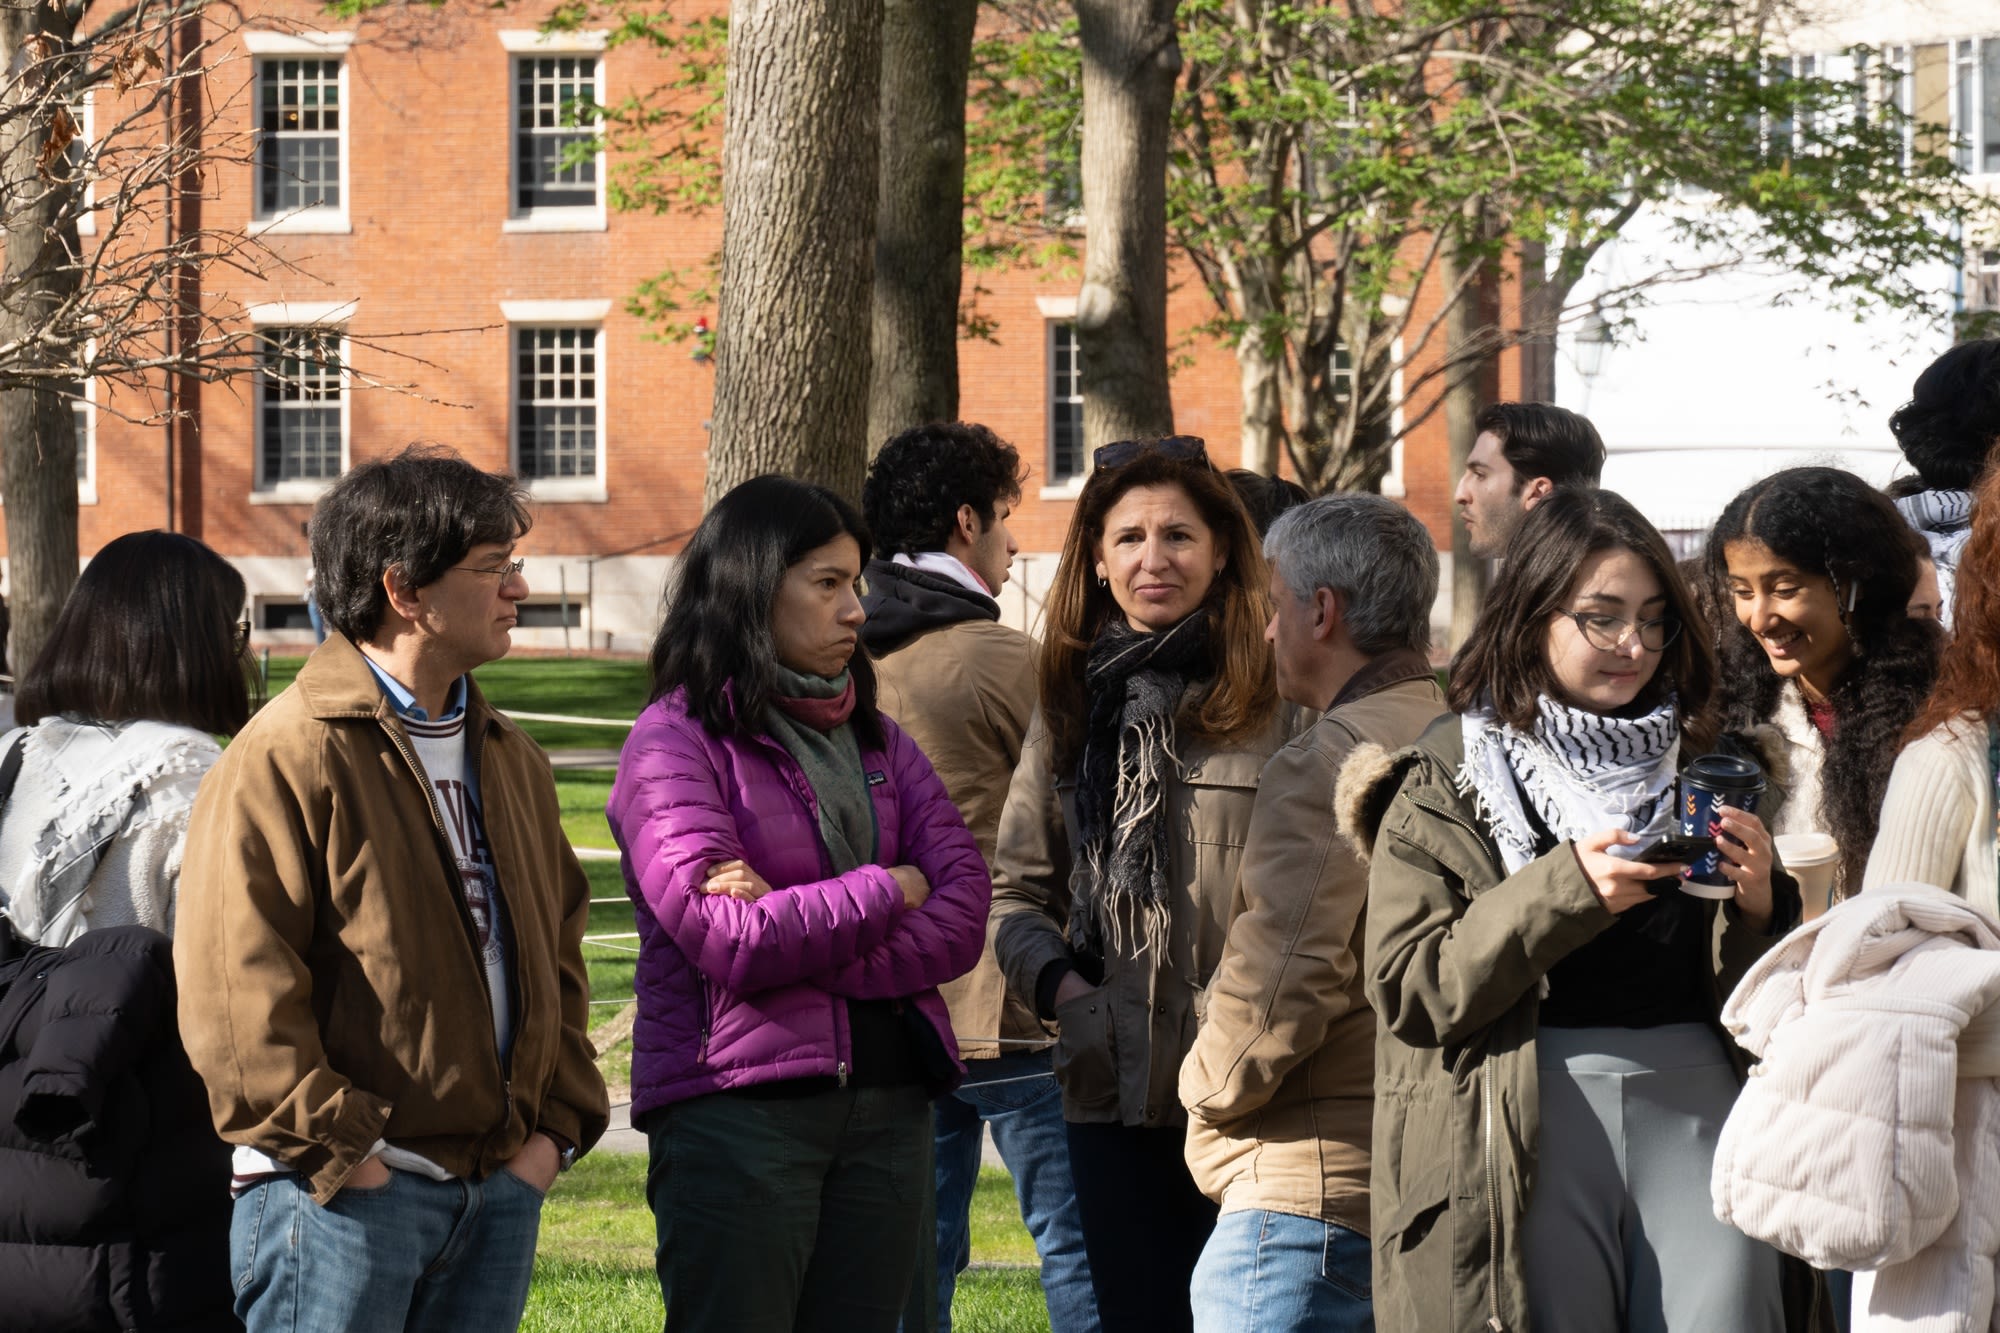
[1070,610,1208,957]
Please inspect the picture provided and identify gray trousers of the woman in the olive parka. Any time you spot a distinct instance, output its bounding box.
[1522,1023,1784,1333]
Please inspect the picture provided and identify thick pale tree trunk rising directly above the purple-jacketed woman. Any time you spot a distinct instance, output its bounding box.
[706,0,882,504]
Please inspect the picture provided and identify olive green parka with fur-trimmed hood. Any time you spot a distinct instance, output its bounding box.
[1338,715,1798,1333]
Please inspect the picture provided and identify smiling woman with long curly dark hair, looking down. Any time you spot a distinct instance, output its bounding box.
[1704,468,1944,919]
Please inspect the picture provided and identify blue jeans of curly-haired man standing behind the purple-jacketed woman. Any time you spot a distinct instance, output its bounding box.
[932,1051,1098,1333]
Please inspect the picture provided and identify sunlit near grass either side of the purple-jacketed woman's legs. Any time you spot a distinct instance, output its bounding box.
[520,1153,1048,1333]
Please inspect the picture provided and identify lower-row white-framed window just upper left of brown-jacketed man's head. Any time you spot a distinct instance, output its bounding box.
[256,324,348,498]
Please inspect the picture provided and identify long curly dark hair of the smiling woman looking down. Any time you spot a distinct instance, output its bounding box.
[1704,468,1942,893]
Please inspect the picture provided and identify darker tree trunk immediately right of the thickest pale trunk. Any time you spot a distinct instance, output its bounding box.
[868,0,980,454]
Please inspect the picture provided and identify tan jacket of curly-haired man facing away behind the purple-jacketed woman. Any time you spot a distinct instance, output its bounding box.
[876,620,1050,1061]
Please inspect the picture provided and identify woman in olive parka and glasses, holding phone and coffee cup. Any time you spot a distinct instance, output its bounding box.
[1340,490,1796,1333]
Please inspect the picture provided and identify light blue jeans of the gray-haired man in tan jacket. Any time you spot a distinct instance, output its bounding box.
[1190,1209,1374,1333]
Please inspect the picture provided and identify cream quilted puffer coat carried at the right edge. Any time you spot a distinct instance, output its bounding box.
[1712,885,2000,1333]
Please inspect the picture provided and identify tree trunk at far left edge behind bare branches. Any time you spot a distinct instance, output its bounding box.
[0,4,78,673]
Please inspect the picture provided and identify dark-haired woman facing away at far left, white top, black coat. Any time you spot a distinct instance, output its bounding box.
[0,532,250,1331]
